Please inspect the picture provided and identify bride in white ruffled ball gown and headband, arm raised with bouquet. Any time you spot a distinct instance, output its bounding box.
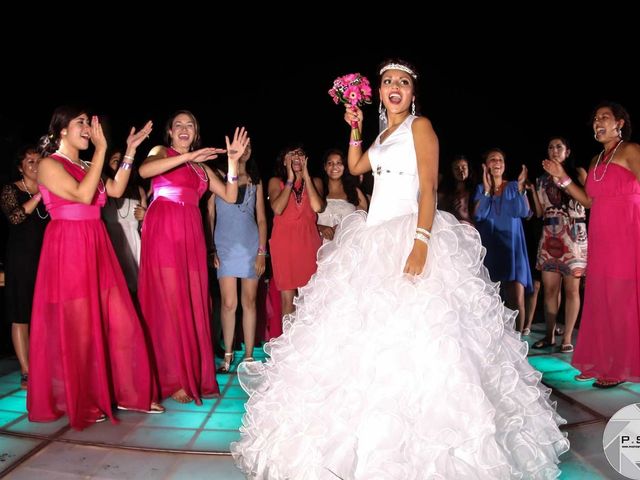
[231,60,569,480]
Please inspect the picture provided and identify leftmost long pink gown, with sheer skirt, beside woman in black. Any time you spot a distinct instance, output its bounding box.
[27,155,157,429]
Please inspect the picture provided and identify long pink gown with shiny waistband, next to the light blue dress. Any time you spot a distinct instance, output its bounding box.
[138,149,220,404]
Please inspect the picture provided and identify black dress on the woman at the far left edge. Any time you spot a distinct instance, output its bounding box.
[0,183,49,323]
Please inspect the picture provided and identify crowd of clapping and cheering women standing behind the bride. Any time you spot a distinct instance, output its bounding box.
[0,81,640,464]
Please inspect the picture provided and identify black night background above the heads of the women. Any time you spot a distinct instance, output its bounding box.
[0,19,640,343]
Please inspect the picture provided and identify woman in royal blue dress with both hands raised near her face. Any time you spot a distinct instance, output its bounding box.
[473,148,533,332]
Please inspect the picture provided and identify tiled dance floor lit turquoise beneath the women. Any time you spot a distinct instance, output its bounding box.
[0,330,640,480]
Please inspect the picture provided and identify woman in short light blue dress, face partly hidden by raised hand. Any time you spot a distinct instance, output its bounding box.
[209,139,267,373]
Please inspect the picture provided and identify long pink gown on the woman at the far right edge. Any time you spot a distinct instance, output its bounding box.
[572,163,640,382]
